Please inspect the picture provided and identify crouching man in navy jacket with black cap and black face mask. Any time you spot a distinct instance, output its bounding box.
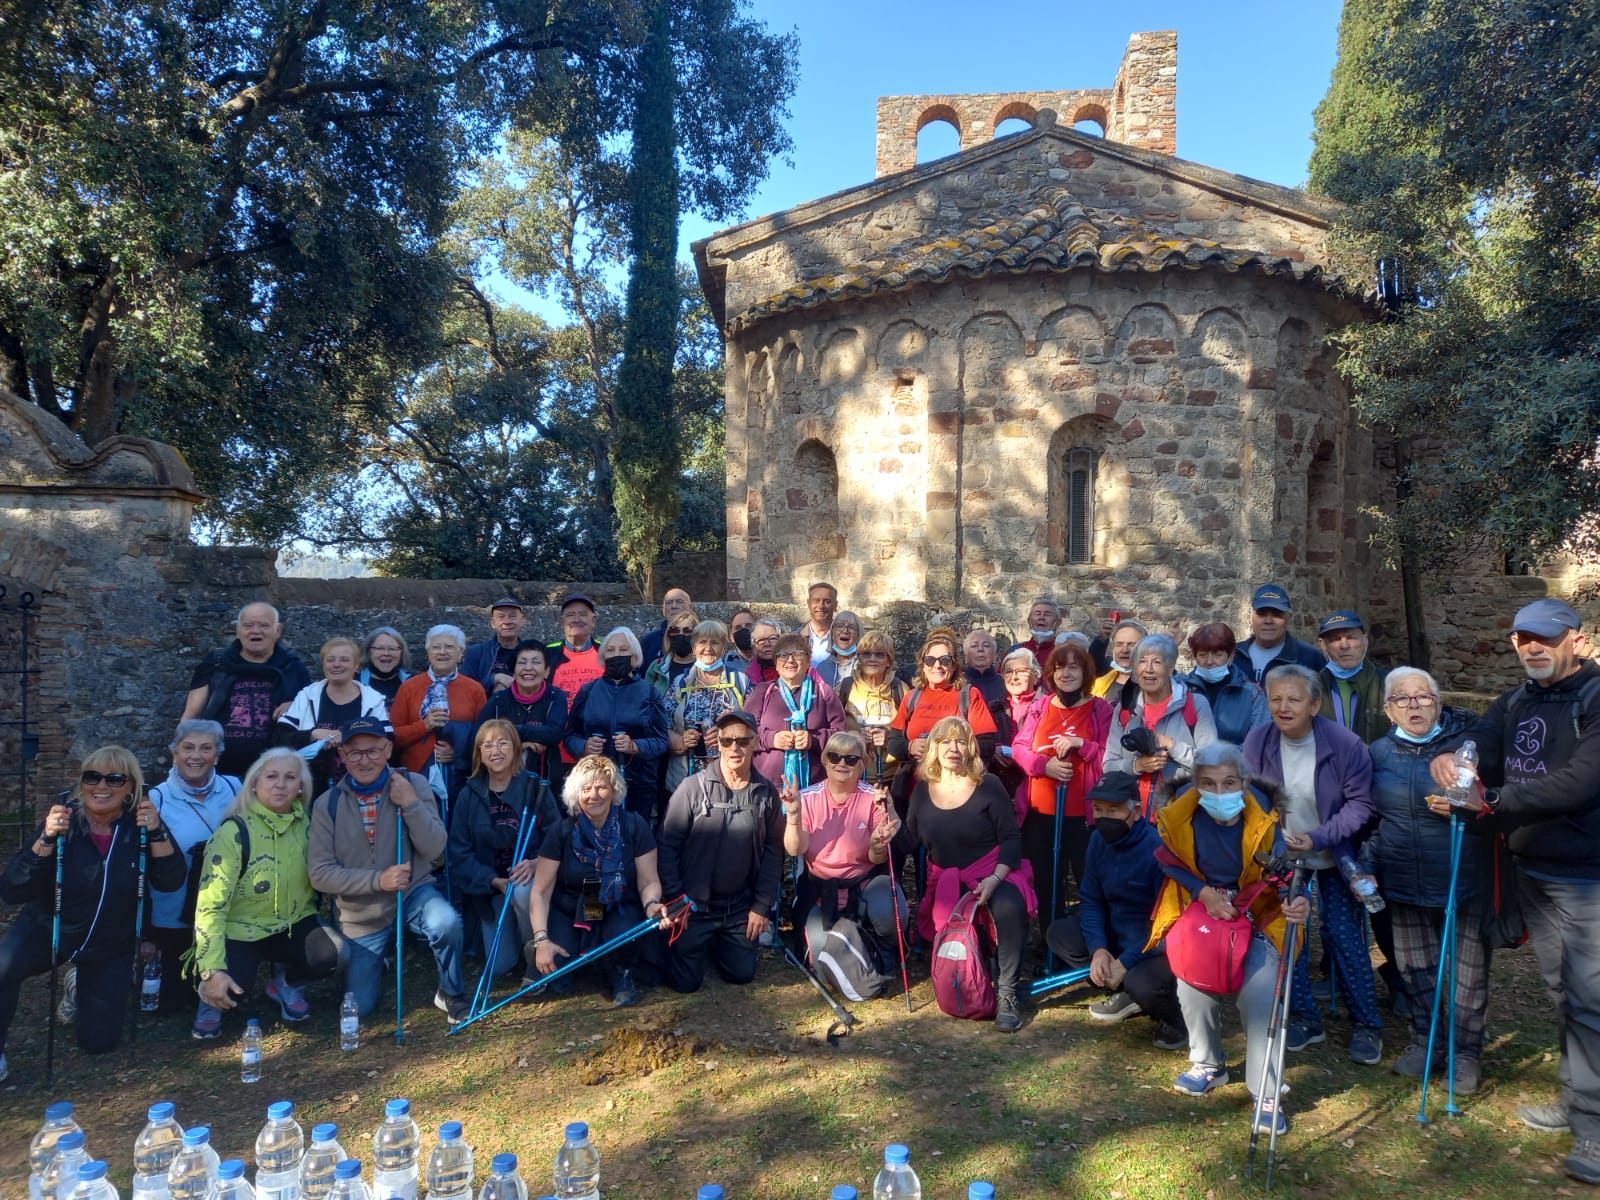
[1045,771,1189,1050]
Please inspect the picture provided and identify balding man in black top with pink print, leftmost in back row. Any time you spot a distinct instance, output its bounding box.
[179,603,310,778]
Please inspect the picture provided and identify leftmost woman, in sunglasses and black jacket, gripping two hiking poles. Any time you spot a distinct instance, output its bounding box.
[0,746,184,1078]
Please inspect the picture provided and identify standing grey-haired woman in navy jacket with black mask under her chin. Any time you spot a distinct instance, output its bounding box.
[562,627,667,821]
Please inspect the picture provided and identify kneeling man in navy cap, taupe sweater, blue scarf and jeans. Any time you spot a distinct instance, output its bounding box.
[306,717,469,1024]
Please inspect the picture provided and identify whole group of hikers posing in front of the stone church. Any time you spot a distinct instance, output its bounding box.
[0,584,1600,1182]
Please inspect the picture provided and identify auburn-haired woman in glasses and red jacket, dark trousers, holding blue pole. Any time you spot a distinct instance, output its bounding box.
[1011,649,1110,928]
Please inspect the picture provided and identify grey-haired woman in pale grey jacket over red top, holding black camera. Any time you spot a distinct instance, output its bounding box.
[1102,634,1216,816]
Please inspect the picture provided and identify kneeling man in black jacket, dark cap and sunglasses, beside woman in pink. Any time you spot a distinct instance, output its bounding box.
[656,709,784,992]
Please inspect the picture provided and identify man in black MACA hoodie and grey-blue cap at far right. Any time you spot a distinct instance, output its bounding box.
[1430,600,1600,1184]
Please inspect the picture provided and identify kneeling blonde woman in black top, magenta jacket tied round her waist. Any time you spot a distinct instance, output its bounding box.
[906,720,1038,1034]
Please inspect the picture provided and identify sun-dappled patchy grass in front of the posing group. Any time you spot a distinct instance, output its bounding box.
[0,947,1586,1200]
